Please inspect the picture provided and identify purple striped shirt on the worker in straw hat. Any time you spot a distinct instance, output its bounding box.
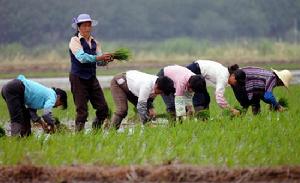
[242,67,277,100]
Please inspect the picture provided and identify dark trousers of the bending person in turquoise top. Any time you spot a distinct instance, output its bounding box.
[1,79,31,136]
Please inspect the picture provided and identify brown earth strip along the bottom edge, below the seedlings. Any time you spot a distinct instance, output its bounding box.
[0,164,300,183]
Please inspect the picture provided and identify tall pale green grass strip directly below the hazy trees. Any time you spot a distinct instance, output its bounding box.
[0,37,300,64]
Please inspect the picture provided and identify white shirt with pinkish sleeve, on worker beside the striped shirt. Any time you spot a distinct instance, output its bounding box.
[195,60,229,108]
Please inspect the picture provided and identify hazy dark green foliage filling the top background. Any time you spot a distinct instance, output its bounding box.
[0,0,300,45]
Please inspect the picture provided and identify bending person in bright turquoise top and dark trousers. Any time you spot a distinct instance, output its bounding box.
[1,75,68,137]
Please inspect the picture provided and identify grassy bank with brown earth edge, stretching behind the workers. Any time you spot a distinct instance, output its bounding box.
[0,38,300,78]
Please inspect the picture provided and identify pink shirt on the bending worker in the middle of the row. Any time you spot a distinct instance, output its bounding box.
[164,65,195,96]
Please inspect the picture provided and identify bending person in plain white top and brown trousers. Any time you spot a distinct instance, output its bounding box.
[110,70,175,129]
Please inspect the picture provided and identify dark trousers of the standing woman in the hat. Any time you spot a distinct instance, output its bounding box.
[69,73,108,124]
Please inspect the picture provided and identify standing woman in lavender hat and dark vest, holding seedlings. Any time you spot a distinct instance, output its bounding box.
[69,14,113,131]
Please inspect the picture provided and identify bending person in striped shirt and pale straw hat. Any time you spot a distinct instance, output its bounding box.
[228,64,292,115]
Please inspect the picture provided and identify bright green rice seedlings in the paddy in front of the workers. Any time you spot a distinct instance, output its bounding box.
[0,85,300,167]
